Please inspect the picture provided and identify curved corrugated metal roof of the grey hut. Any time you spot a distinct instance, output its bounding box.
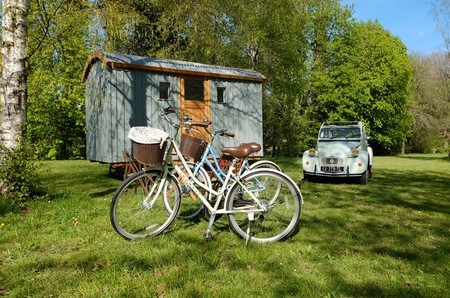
[82,51,267,82]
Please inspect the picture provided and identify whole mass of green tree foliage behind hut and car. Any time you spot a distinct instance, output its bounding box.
[0,0,432,159]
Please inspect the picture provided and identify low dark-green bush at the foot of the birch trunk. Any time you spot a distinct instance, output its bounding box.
[0,142,44,204]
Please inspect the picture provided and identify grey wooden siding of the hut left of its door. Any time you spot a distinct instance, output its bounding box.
[86,63,179,163]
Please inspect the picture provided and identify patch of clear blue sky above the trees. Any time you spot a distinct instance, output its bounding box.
[341,0,445,55]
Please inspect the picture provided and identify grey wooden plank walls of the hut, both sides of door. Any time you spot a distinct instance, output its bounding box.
[86,54,263,163]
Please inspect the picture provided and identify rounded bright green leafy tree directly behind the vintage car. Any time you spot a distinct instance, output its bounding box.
[309,21,412,153]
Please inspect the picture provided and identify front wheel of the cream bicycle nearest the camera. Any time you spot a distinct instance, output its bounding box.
[110,171,181,240]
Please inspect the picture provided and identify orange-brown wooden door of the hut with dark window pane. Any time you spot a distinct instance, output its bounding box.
[180,77,211,142]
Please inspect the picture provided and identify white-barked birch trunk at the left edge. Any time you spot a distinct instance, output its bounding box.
[0,0,29,149]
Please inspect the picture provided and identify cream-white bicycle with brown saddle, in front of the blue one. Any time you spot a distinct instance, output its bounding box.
[110,108,303,243]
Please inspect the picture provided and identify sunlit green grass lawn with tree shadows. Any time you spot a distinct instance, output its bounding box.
[0,154,450,297]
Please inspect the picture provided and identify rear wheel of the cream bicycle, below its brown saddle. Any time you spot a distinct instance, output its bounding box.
[226,169,303,243]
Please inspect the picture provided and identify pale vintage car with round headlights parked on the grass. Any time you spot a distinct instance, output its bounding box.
[302,122,373,184]
